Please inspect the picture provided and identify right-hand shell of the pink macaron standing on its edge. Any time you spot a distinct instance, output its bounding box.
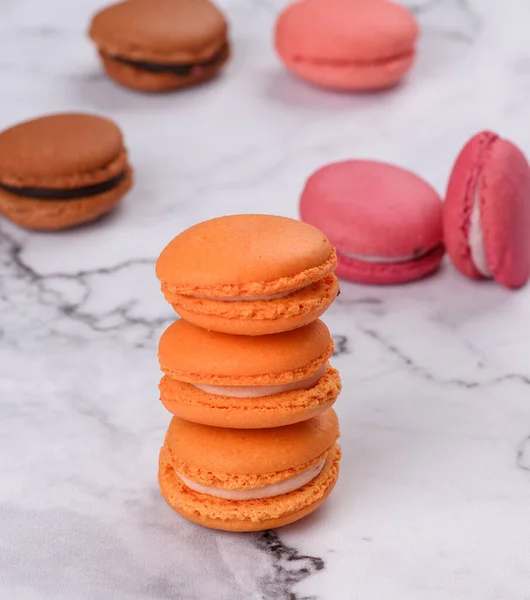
[479,138,530,288]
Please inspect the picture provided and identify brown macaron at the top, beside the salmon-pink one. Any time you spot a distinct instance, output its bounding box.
[89,0,230,92]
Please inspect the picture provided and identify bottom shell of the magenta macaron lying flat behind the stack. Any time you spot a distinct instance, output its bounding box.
[336,244,445,285]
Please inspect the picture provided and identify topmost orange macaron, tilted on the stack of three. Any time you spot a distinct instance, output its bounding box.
[156,214,339,335]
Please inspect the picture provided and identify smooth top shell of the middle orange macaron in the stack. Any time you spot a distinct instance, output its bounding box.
[158,319,333,386]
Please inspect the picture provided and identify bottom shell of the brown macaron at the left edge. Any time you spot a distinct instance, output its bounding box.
[0,166,133,231]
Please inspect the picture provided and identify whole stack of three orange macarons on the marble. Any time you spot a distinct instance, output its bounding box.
[156,215,341,531]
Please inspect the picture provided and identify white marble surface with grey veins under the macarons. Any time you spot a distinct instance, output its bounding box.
[0,0,530,600]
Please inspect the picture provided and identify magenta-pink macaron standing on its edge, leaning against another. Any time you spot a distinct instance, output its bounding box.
[444,131,530,288]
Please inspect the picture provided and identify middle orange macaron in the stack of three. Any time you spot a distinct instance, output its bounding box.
[158,319,341,429]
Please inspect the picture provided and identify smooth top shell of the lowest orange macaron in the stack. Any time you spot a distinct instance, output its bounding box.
[166,409,339,475]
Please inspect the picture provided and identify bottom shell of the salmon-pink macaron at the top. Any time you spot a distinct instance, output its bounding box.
[278,54,415,91]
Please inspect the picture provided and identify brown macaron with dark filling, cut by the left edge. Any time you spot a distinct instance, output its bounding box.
[0,114,132,230]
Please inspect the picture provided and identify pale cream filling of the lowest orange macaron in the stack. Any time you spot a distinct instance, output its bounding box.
[175,459,326,500]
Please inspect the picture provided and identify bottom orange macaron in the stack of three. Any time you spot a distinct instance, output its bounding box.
[158,409,341,531]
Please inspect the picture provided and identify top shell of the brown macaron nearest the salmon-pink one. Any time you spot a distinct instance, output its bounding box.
[90,0,227,63]
